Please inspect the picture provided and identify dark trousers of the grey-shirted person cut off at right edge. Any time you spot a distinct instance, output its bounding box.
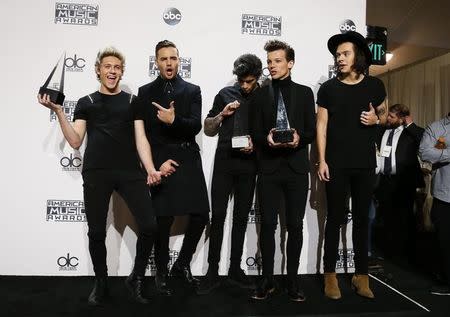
[431,198,450,286]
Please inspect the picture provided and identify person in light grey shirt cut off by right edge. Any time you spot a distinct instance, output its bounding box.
[419,112,450,295]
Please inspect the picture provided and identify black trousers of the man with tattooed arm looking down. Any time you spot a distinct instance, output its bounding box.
[208,170,256,273]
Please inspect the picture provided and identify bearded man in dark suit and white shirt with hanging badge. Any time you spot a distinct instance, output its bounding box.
[375,104,425,260]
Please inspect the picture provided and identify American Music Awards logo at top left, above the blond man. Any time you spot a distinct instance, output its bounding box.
[55,2,98,26]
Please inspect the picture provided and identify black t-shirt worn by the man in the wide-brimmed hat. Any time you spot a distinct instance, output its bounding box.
[317,76,386,168]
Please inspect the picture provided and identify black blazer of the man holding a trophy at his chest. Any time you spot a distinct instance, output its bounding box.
[249,81,316,173]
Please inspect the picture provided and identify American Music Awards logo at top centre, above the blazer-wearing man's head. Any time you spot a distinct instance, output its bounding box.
[241,14,281,36]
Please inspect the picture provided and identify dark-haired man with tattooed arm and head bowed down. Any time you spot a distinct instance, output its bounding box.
[198,54,262,294]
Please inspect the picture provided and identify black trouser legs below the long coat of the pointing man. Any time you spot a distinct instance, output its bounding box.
[155,213,208,274]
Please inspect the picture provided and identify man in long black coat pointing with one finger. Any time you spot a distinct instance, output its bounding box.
[134,40,209,296]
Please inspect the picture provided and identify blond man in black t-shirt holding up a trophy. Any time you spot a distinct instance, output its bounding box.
[38,47,161,306]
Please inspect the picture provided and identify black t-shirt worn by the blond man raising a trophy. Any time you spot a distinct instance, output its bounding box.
[73,91,139,171]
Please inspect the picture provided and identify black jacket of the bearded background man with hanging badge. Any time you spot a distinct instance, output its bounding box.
[377,123,425,188]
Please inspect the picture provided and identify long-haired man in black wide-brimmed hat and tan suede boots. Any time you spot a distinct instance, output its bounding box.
[317,32,387,299]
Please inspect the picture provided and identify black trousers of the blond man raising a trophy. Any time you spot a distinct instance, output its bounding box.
[83,169,156,276]
